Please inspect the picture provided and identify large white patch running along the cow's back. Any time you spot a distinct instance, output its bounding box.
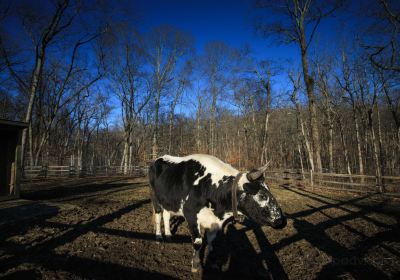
[161,154,239,186]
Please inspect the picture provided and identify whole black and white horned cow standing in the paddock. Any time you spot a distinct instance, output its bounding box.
[149,154,286,272]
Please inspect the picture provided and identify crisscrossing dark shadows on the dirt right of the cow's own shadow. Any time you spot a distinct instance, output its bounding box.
[282,185,400,279]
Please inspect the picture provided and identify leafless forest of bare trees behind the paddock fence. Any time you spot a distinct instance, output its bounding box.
[0,0,400,177]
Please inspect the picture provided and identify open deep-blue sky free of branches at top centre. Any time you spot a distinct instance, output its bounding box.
[133,0,295,58]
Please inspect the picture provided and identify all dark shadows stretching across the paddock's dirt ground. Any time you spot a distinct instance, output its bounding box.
[0,178,400,279]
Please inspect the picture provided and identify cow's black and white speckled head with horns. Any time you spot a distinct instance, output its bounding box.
[238,164,286,229]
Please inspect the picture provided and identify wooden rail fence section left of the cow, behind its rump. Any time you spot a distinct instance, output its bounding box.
[23,165,148,180]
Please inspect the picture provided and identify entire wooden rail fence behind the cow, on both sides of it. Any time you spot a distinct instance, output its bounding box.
[23,164,400,195]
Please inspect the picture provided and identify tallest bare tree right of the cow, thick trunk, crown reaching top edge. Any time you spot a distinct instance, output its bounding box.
[258,0,342,171]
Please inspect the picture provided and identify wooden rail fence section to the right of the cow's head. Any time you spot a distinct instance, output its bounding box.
[265,170,400,194]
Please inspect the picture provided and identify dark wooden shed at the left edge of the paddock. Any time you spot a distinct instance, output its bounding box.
[0,119,28,200]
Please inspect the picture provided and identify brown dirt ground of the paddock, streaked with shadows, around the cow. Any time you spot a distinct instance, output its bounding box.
[0,178,400,279]
